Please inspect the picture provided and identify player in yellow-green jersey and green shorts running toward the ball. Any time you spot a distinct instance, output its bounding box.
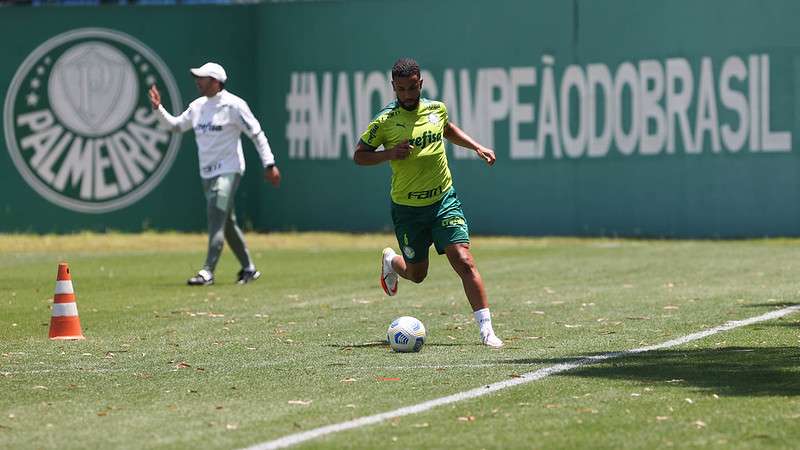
[353,58,503,348]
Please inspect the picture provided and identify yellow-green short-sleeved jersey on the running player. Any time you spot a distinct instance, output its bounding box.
[361,98,453,206]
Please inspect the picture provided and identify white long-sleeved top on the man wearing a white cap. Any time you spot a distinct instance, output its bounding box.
[157,90,275,178]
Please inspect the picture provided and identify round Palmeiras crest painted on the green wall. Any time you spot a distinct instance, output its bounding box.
[3,28,182,213]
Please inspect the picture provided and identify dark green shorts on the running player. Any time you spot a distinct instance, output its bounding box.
[392,188,469,263]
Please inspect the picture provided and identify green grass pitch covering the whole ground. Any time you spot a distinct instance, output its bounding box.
[0,234,800,449]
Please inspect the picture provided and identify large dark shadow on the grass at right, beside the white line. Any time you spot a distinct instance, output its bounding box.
[503,346,800,397]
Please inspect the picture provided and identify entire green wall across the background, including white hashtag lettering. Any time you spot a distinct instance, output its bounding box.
[0,0,800,237]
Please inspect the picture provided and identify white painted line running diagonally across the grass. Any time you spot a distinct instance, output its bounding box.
[246,305,800,450]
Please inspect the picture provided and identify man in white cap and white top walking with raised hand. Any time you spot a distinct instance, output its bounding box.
[149,62,281,286]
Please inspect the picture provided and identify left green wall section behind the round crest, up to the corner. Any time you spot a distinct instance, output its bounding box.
[0,7,260,232]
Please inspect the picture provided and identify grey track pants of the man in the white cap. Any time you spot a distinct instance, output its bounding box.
[203,173,253,273]
